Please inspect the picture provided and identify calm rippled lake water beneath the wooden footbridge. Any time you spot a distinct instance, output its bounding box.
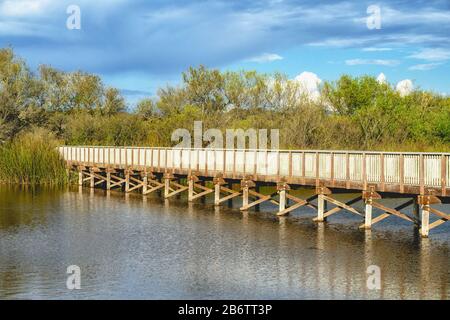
[0,186,450,299]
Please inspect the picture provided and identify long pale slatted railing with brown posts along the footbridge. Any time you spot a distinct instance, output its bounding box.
[59,146,450,197]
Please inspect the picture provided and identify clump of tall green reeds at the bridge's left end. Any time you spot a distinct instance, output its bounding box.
[0,130,68,185]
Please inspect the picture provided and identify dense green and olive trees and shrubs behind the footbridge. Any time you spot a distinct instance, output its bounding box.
[0,49,450,151]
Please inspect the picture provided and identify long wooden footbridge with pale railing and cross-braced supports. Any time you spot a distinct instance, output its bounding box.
[59,146,450,237]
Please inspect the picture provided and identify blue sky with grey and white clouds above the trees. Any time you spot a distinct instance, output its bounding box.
[0,0,450,103]
